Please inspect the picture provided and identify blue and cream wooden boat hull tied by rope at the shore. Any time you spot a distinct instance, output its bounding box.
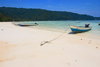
[69,25,92,33]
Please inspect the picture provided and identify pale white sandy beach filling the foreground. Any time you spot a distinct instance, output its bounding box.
[0,22,100,67]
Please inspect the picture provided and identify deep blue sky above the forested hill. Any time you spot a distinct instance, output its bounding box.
[0,0,100,17]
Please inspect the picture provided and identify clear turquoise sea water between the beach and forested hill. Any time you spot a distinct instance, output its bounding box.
[14,20,100,37]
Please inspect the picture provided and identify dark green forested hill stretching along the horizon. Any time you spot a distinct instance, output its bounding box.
[0,7,100,21]
